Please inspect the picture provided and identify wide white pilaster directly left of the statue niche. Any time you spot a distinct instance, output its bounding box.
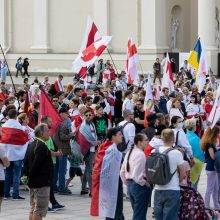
[138,0,168,54]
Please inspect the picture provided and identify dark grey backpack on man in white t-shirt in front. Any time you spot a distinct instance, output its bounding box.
[146,147,176,185]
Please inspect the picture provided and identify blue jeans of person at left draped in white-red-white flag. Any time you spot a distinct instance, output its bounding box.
[4,160,23,198]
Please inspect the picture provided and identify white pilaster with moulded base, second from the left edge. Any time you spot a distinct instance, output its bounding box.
[31,0,49,53]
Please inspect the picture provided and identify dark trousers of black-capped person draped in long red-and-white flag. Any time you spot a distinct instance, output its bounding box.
[105,177,125,220]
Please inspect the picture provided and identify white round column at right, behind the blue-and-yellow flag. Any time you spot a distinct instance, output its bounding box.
[198,0,218,74]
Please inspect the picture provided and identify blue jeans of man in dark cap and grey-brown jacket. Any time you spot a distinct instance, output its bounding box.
[58,155,67,191]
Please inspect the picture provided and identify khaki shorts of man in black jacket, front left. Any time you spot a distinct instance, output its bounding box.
[30,186,50,217]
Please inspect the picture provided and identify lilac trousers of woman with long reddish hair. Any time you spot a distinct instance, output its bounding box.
[204,171,220,209]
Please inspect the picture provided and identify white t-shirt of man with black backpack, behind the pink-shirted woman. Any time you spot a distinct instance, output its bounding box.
[119,121,135,153]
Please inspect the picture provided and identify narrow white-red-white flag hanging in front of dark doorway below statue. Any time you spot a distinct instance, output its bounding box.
[162,53,174,92]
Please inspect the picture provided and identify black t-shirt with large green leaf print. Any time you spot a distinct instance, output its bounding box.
[93,114,108,139]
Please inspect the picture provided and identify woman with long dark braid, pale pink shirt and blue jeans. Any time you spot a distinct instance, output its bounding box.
[120,133,151,220]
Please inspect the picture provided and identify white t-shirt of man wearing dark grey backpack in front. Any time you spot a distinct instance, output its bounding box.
[155,147,184,190]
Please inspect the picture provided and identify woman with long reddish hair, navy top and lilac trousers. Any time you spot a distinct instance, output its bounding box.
[200,126,220,210]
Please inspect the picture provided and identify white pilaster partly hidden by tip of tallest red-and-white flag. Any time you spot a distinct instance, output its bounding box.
[93,0,109,35]
